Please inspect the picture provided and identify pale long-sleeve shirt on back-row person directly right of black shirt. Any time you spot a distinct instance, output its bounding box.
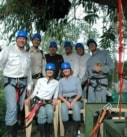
[63,53,79,76]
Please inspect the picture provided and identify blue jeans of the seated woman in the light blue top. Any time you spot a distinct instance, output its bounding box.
[61,101,83,122]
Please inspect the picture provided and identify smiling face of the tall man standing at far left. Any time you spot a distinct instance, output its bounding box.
[16,37,27,50]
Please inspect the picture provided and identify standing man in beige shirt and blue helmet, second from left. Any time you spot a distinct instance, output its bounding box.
[29,33,46,88]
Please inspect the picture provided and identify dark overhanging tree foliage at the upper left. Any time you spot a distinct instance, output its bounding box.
[0,0,70,40]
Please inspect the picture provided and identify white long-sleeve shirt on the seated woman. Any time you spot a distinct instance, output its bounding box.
[30,77,59,100]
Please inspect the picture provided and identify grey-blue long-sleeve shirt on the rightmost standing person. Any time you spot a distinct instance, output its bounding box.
[82,49,114,83]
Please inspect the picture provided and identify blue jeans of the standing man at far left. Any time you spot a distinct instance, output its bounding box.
[4,77,27,125]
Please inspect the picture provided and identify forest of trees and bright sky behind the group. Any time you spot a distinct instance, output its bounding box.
[0,0,127,136]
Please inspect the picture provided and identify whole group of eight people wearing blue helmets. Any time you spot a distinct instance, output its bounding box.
[0,30,114,137]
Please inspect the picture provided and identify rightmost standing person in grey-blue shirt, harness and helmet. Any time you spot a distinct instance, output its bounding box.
[82,39,114,103]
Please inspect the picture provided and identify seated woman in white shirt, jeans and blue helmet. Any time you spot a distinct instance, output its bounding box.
[25,63,59,137]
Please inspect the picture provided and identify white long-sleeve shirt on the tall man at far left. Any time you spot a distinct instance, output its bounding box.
[0,44,32,89]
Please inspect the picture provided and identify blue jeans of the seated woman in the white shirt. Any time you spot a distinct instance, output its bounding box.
[37,104,54,124]
